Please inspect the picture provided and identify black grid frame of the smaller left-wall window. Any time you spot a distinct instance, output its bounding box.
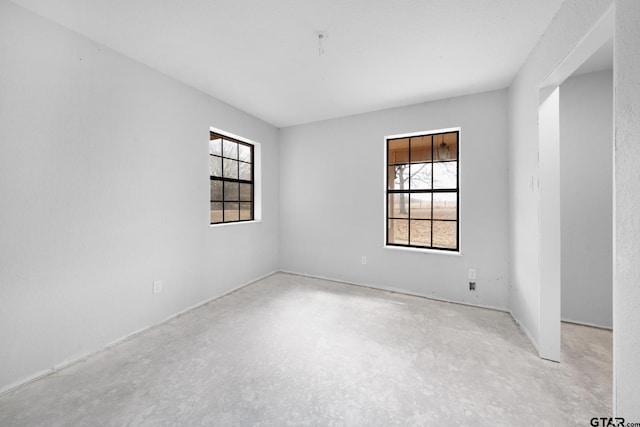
[209,130,256,225]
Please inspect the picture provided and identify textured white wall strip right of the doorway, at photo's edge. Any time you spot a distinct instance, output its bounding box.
[613,0,640,416]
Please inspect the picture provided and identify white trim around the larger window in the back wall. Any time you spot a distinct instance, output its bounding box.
[382,127,462,256]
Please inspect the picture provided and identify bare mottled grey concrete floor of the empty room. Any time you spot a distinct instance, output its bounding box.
[0,273,612,426]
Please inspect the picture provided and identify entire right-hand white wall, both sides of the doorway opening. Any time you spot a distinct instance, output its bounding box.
[509,0,640,420]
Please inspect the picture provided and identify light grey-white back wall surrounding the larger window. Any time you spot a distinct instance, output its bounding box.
[280,90,509,308]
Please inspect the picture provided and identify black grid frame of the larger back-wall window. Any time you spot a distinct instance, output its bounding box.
[385,129,460,253]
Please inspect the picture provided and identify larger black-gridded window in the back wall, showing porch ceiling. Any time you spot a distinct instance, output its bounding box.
[386,130,459,251]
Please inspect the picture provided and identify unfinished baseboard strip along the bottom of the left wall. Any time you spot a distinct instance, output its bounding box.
[0,270,278,396]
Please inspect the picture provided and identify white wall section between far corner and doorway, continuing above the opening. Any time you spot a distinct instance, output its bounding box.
[509,0,612,358]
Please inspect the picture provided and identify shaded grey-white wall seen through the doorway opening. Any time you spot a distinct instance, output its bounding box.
[560,70,613,328]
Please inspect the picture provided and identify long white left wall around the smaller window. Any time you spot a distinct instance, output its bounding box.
[0,0,278,390]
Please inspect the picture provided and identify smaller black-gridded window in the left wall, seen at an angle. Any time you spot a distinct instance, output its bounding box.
[209,132,254,224]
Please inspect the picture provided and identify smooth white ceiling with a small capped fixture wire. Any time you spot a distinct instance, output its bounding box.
[13,0,562,127]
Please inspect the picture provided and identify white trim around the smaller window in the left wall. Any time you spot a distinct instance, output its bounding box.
[207,126,262,228]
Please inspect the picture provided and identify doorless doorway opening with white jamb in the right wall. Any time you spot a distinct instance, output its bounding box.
[538,3,614,372]
